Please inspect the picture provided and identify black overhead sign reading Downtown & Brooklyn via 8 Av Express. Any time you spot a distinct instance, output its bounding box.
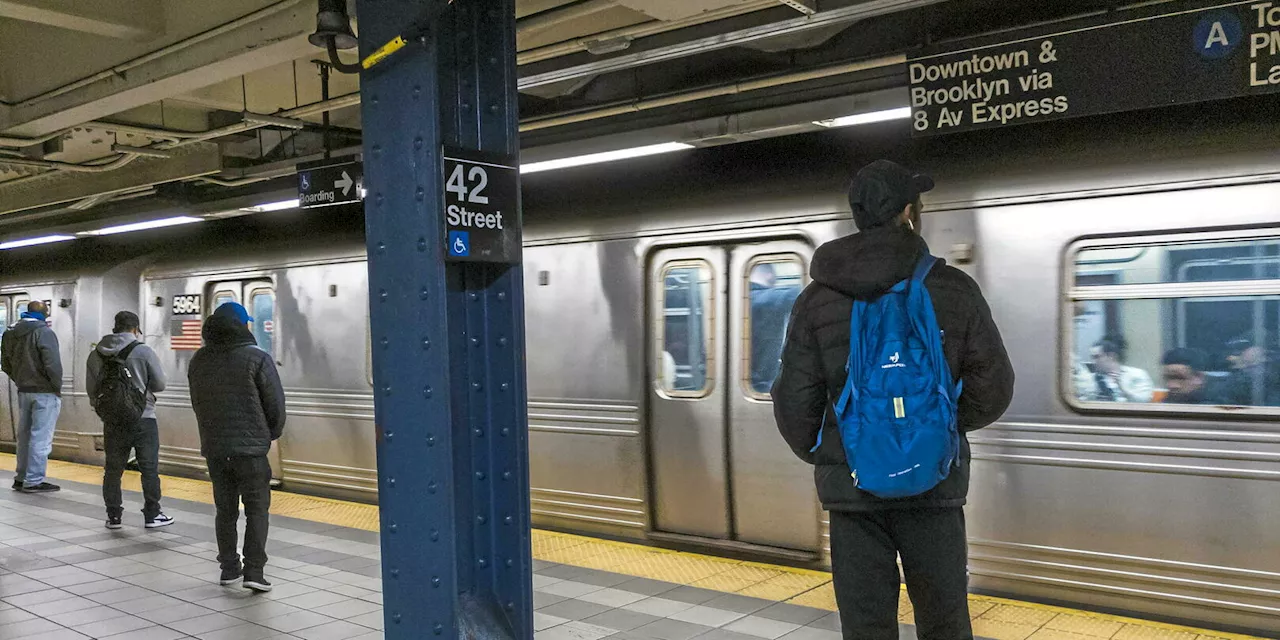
[908,0,1280,136]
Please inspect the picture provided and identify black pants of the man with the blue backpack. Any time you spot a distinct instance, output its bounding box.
[831,507,973,640]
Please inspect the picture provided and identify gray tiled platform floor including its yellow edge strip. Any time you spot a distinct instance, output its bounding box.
[0,454,1249,640]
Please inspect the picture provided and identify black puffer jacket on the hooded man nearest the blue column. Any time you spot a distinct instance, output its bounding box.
[187,316,284,458]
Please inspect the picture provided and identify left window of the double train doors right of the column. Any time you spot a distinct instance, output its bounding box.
[657,260,716,397]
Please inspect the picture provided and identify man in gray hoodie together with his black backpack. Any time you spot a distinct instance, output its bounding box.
[84,311,173,529]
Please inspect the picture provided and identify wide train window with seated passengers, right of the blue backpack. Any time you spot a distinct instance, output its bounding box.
[1064,232,1280,411]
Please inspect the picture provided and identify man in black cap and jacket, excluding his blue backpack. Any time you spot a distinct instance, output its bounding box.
[773,160,1014,640]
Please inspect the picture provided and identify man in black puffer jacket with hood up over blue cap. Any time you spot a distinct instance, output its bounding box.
[187,302,284,591]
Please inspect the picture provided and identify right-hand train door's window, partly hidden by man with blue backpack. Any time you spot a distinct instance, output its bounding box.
[742,253,804,399]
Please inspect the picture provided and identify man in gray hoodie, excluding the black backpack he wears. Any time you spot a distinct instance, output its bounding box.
[84,311,173,529]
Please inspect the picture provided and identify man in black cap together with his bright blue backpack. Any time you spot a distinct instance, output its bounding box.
[772,160,1014,640]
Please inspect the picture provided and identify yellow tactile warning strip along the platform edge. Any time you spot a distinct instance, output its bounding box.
[0,453,1261,640]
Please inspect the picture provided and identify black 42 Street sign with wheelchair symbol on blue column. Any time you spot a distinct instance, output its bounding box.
[442,148,522,264]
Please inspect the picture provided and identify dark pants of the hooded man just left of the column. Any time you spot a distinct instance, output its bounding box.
[205,456,271,577]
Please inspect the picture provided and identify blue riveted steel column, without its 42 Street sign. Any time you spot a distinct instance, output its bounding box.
[357,0,534,640]
